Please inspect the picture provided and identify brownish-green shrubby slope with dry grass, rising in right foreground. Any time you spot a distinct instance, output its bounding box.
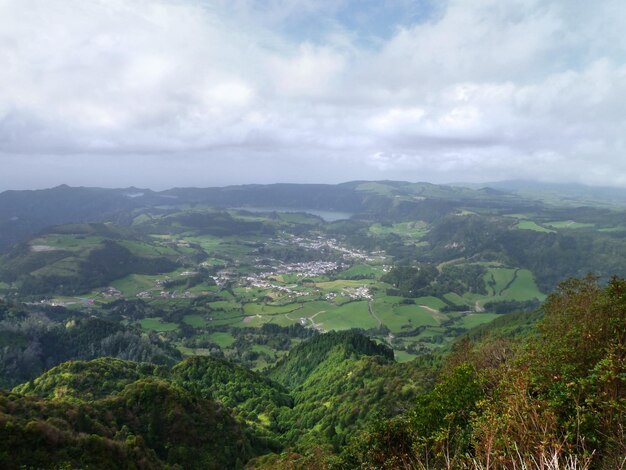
[294,277,626,469]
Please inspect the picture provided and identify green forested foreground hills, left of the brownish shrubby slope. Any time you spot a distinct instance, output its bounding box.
[0,332,432,469]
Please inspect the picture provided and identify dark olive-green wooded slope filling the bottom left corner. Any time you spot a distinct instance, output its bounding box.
[0,378,257,469]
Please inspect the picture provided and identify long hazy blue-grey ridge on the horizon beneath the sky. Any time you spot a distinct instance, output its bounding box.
[0,181,537,252]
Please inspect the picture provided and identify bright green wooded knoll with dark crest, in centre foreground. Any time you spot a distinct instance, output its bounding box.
[269,331,433,449]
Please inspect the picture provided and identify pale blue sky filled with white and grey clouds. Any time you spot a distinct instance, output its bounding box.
[0,0,626,191]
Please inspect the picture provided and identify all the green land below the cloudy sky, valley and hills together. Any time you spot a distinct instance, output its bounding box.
[0,182,626,469]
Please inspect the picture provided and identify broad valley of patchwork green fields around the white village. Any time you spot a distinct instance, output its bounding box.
[0,183,622,368]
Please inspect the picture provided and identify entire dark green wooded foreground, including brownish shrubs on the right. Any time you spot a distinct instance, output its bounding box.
[0,277,626,470]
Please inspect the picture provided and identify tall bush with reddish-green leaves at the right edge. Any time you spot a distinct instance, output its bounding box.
[532,277,626,458]
